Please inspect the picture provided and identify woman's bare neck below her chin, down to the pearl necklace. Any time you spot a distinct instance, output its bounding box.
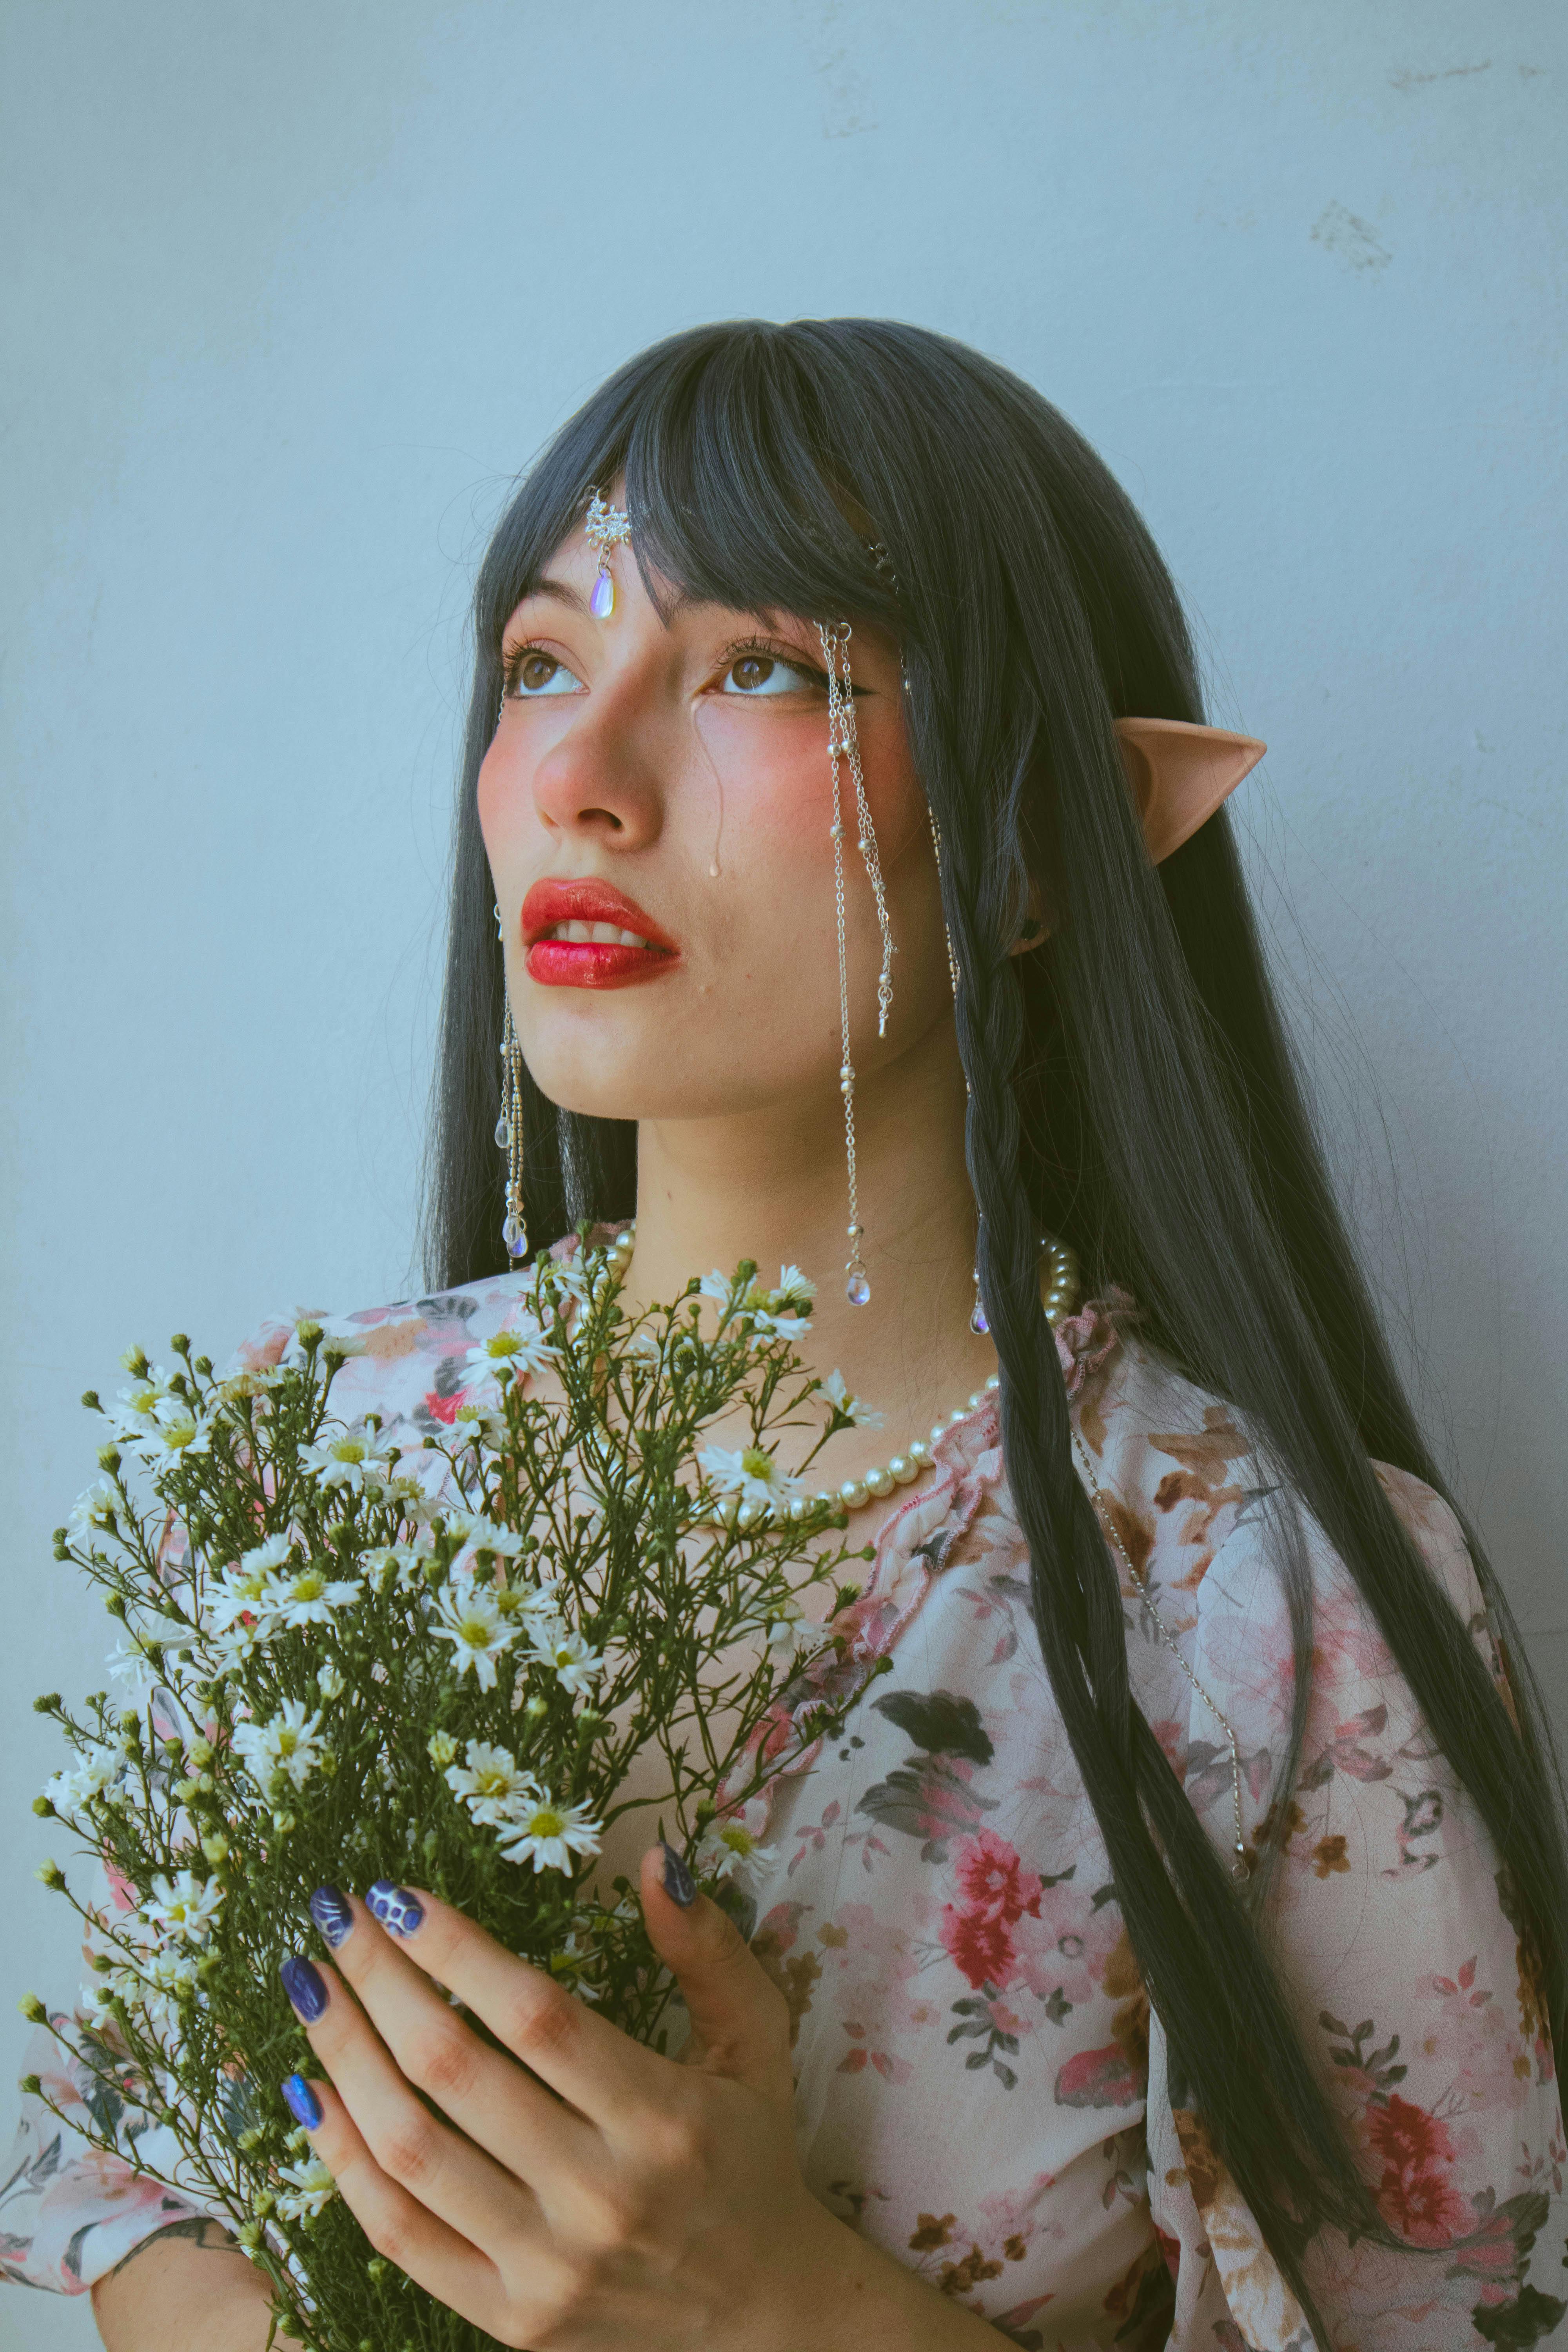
[628,1018,997,1482]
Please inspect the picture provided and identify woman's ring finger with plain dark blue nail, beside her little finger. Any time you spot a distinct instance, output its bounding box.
[282,1959,538,2256]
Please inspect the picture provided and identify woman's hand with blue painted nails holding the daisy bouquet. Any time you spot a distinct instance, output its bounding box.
[285,1846,990,2352]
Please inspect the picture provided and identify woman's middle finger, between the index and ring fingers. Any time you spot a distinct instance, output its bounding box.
[310,1886,592,2187]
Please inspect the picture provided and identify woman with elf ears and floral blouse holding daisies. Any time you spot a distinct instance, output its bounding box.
[16,320,1568,2352]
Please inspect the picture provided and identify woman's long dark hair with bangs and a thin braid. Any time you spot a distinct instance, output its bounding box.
[428,320,1568,2326]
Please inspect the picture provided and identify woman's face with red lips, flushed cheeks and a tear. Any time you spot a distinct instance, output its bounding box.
[477,501,952,1120]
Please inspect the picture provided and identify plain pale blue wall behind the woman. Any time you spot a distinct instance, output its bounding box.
[0,0,1568,2352]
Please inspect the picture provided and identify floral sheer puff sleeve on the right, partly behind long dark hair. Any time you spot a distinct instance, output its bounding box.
[1147,1465,1568,2352]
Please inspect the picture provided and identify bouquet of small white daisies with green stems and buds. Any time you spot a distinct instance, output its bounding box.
[24,1235,884,2352]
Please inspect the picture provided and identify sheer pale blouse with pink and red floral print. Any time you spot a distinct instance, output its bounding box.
[0,1242,1568,2352]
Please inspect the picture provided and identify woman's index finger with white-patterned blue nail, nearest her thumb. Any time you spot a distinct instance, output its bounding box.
[345,1882,670,2131]
